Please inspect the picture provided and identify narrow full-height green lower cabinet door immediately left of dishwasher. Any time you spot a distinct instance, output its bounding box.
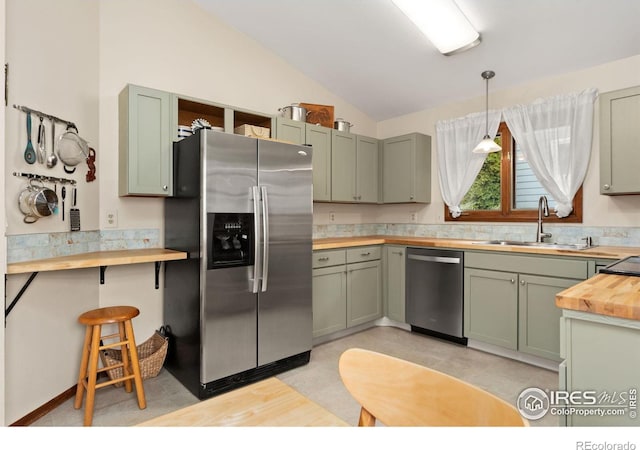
[383,245,407,323]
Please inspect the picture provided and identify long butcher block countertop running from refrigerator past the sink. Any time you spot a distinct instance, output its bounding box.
[313,236,640,260]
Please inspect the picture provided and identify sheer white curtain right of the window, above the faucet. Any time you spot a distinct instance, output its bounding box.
[502,89,597,217]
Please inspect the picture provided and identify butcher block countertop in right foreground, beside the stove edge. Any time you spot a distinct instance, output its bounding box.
[556,273,640,320]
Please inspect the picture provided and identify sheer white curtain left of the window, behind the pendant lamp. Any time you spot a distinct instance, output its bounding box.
[436,111,501,218]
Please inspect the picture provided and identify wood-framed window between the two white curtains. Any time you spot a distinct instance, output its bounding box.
[444,122,582,223]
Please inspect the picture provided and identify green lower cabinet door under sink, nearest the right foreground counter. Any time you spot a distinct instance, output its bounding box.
[518,275,581,361]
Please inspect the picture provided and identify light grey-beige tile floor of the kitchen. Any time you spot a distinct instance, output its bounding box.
[33,327,558,427]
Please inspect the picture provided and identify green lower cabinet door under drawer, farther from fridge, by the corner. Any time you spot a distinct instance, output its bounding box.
[347,260,382,327]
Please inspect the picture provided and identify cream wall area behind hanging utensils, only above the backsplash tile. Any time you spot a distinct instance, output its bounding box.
[5,0,100,234]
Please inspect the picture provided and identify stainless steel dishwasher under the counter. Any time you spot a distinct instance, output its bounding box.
[406,247,467,345]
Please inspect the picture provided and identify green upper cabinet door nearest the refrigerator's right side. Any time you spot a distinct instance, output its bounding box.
[305,123,331,202]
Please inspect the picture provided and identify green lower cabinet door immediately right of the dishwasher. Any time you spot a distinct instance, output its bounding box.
[464,269,518,350]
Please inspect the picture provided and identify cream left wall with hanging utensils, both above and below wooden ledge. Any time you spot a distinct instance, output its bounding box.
[1,0,101,424]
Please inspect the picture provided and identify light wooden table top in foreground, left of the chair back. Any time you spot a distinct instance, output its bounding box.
[137,378,349,427]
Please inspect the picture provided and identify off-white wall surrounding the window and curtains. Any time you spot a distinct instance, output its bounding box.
[376,55,640,227]
